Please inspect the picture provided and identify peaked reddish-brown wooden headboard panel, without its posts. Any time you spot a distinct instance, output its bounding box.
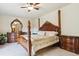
[39,21,59,31]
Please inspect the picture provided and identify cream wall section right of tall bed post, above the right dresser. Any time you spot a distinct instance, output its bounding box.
[61,3,79,36]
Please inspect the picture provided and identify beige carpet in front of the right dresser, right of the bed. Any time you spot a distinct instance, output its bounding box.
[37,47,78,56]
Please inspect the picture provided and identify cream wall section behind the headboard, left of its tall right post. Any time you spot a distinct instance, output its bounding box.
[33,10,58,28]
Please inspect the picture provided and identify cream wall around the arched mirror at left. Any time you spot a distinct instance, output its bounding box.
[0,16,27,32]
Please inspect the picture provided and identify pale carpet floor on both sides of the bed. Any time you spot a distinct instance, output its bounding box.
[0,43,77,56]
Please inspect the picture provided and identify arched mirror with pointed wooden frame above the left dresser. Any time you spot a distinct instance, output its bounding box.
[11,19,23,34]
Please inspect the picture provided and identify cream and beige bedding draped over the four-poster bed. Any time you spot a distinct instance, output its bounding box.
[22,35,59,55]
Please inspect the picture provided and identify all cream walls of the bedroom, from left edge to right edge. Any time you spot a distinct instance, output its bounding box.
[0,3,79,36]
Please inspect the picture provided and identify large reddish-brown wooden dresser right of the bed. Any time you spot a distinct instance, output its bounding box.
[60,35,79,54]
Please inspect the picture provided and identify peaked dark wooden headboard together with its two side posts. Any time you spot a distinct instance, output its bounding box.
[38,10,61,36]
